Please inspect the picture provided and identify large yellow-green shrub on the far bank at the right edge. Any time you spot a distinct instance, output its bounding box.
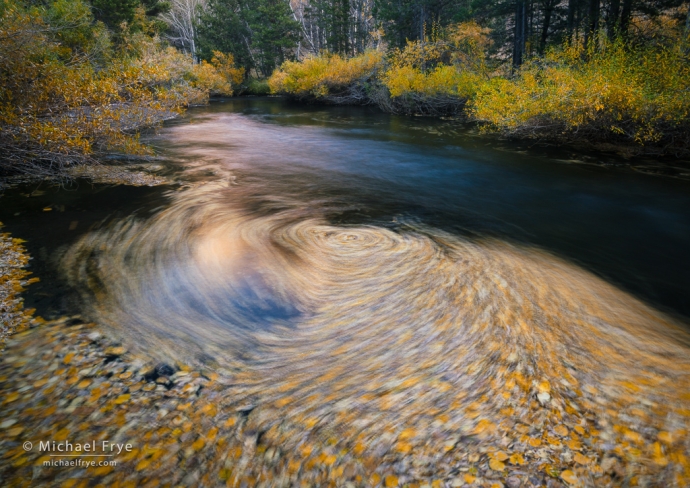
[469,40,690,154]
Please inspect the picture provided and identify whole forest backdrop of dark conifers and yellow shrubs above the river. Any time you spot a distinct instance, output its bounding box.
[0,0,690,173]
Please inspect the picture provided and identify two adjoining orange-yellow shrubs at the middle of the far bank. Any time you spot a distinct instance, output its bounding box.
[269,22,489,114]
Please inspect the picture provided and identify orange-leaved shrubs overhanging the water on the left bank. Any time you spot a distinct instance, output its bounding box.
[0,0,241,172]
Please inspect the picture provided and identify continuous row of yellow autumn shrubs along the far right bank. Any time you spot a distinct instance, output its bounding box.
[271,20,690,155]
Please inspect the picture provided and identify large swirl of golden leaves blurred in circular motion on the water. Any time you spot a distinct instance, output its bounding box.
[65,173,690,428]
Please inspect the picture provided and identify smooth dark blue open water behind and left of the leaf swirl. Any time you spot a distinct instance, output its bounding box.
[0,99,690,320]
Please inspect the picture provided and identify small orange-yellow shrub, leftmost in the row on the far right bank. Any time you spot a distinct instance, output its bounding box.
[268,51,383,103]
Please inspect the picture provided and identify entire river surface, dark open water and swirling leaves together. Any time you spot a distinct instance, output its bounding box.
[0,99,690,486]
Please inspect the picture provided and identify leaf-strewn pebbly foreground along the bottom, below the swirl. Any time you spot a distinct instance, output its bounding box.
[0,258,690,488]
